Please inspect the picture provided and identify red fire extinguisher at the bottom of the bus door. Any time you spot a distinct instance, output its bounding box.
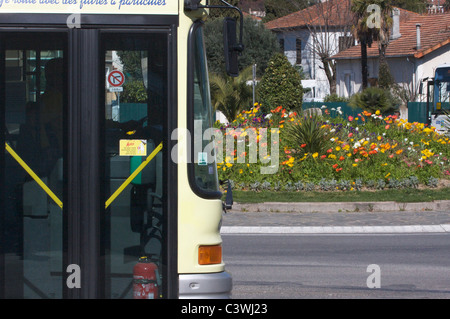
[133,256,158,299]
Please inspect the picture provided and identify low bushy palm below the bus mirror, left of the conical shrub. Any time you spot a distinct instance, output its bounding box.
[209,66,253,122]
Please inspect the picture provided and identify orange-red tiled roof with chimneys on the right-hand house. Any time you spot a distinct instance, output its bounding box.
[332,10,450,59]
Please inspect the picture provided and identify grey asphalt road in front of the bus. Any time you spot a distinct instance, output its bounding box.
[223,233,450,299]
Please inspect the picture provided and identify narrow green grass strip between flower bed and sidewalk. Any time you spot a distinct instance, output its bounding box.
[224,187,450,203]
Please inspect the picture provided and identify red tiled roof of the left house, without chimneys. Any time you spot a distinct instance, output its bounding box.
[265,0,352,31]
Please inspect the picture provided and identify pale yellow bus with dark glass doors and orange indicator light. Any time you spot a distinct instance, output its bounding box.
[0,0,242,299]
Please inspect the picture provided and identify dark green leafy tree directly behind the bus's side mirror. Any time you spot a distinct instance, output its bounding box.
[205,18,280,76]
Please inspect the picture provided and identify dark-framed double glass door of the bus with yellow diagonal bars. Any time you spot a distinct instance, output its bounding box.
[0,26,177,298]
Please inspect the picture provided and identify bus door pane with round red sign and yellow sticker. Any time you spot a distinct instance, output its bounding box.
[102,33,168,298]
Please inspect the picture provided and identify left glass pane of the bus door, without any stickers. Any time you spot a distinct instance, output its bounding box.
[0,33,65,298]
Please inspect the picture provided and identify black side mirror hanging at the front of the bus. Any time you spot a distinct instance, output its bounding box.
[223,18,242,77]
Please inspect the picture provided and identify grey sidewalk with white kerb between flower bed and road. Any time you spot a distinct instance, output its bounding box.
[221,201,450,234]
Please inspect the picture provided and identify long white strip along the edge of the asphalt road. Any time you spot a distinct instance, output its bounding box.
[220,224,450,234]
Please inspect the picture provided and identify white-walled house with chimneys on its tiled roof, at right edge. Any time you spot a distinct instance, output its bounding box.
[332,9,450,105]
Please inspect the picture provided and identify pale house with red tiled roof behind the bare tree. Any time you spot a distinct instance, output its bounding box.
[265,0,355,101]
